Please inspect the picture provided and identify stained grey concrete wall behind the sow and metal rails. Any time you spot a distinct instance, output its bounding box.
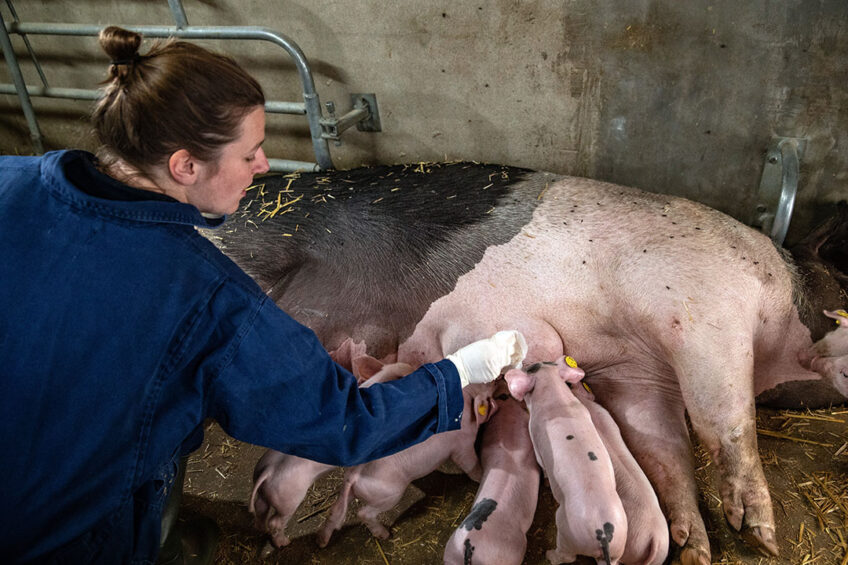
[0,0,848,241]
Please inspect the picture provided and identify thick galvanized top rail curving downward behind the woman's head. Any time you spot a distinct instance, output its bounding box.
[6,23,333,169]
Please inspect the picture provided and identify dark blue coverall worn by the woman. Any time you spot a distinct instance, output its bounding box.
[0,151,463,563]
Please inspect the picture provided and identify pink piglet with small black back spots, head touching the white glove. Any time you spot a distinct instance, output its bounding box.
[504,357,627,565]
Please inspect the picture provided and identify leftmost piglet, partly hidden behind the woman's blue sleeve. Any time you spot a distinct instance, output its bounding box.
[248,360,413,555]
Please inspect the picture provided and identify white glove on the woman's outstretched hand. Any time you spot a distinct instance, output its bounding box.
[446,330,527,387]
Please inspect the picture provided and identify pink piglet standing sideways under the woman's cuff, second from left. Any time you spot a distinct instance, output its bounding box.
[318,383,497,547]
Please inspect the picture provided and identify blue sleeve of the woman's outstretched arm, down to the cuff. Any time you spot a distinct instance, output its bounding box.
[210,299,463,466]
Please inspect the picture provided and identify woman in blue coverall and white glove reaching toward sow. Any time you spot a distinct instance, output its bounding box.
[0,27,526,563]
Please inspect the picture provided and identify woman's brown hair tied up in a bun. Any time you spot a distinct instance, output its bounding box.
[92,26,265,173]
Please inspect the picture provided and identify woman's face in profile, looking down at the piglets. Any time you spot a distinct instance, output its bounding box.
[186,106,268,214]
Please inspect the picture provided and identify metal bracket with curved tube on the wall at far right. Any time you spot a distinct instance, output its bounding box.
[751,137,806,245]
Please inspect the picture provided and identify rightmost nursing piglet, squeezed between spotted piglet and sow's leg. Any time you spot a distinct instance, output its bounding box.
[572,383,668,565]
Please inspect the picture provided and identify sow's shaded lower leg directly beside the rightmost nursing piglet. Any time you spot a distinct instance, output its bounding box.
[588,370,710,565]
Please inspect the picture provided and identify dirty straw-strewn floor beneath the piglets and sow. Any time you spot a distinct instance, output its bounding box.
[182,407,848,565]
